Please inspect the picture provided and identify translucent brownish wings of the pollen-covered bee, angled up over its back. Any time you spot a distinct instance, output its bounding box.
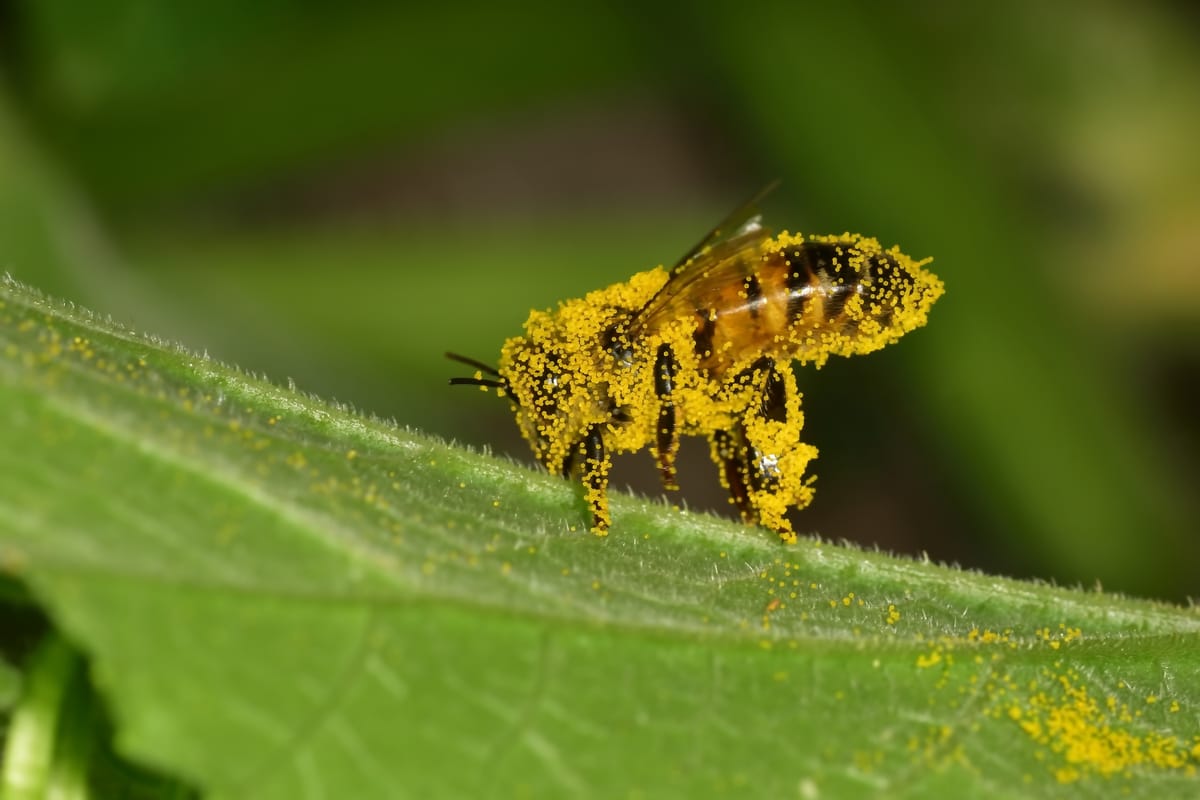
[634,180,779,330]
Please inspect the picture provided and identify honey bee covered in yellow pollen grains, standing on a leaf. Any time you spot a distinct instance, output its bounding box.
[446,185,943,543]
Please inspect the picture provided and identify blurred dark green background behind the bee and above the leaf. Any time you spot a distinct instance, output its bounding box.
[0,0,1200,600]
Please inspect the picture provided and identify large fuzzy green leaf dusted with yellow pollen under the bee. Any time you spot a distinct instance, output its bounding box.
[0,273,1200,798]
